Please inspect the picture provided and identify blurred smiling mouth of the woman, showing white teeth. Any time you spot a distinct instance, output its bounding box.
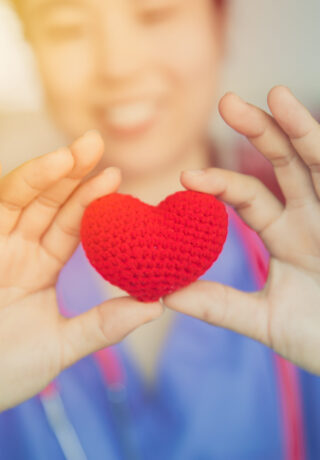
[95,101,159,136]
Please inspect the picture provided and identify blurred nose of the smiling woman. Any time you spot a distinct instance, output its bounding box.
[96,7,146,83]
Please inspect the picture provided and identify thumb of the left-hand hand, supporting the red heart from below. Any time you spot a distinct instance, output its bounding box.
[60,297,163,369]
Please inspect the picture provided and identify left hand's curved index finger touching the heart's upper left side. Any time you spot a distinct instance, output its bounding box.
[40,167,121,265]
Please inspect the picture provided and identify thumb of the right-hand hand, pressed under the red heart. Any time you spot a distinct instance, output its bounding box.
[163,280,270,345]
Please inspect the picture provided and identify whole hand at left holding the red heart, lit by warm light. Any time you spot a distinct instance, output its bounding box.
[0,131,162,411]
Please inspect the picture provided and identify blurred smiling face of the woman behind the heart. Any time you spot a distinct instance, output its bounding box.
[22,0,228,174]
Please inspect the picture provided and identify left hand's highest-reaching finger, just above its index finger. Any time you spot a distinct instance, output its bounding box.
[15,131,104,241]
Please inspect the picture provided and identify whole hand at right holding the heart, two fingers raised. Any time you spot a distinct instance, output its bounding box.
[164,86,320,375]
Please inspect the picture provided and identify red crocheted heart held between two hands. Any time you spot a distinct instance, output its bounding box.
[80,190,228,302]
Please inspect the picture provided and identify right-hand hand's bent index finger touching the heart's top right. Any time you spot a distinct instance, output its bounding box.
[181,168,284,249]
